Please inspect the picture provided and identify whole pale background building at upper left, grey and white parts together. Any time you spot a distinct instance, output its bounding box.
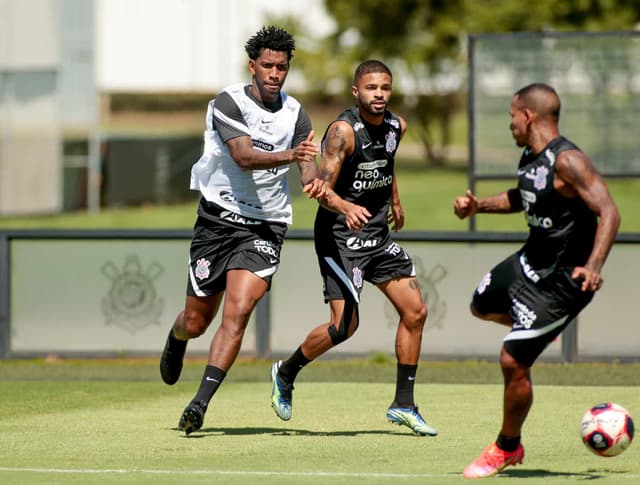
[0,0,332,216]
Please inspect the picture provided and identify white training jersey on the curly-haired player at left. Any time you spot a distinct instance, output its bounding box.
[190,84,300,224]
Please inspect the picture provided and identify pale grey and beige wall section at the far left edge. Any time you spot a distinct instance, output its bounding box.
[0,0,62,215]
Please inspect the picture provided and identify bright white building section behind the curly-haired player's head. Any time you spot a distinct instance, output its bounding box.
[96,0,333,92]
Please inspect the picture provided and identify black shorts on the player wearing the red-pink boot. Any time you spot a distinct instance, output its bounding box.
[473,253,593,366]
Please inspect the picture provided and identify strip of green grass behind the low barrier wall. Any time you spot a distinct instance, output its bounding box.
[0,166,640,232]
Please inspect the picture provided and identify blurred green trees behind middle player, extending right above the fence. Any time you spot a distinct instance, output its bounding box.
[272,0,640,164]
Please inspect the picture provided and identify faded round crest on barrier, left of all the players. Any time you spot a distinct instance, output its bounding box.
[101,254,164,334]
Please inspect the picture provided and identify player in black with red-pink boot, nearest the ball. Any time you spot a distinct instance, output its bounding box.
[453,83,620,478]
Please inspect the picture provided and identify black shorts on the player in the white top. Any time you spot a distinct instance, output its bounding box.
[187,205,287,296]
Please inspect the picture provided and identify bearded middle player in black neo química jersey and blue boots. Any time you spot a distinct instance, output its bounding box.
[271,60,437,436]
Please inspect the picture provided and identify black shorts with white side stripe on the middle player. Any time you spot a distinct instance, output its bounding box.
[316,240,416,303]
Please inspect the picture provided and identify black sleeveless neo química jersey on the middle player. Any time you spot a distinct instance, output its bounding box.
[315,107,402,255]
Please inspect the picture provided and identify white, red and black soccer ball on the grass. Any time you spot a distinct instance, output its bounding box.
[580,402,633,456]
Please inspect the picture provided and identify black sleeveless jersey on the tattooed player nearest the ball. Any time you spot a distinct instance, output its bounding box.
[518,136,598,281]
